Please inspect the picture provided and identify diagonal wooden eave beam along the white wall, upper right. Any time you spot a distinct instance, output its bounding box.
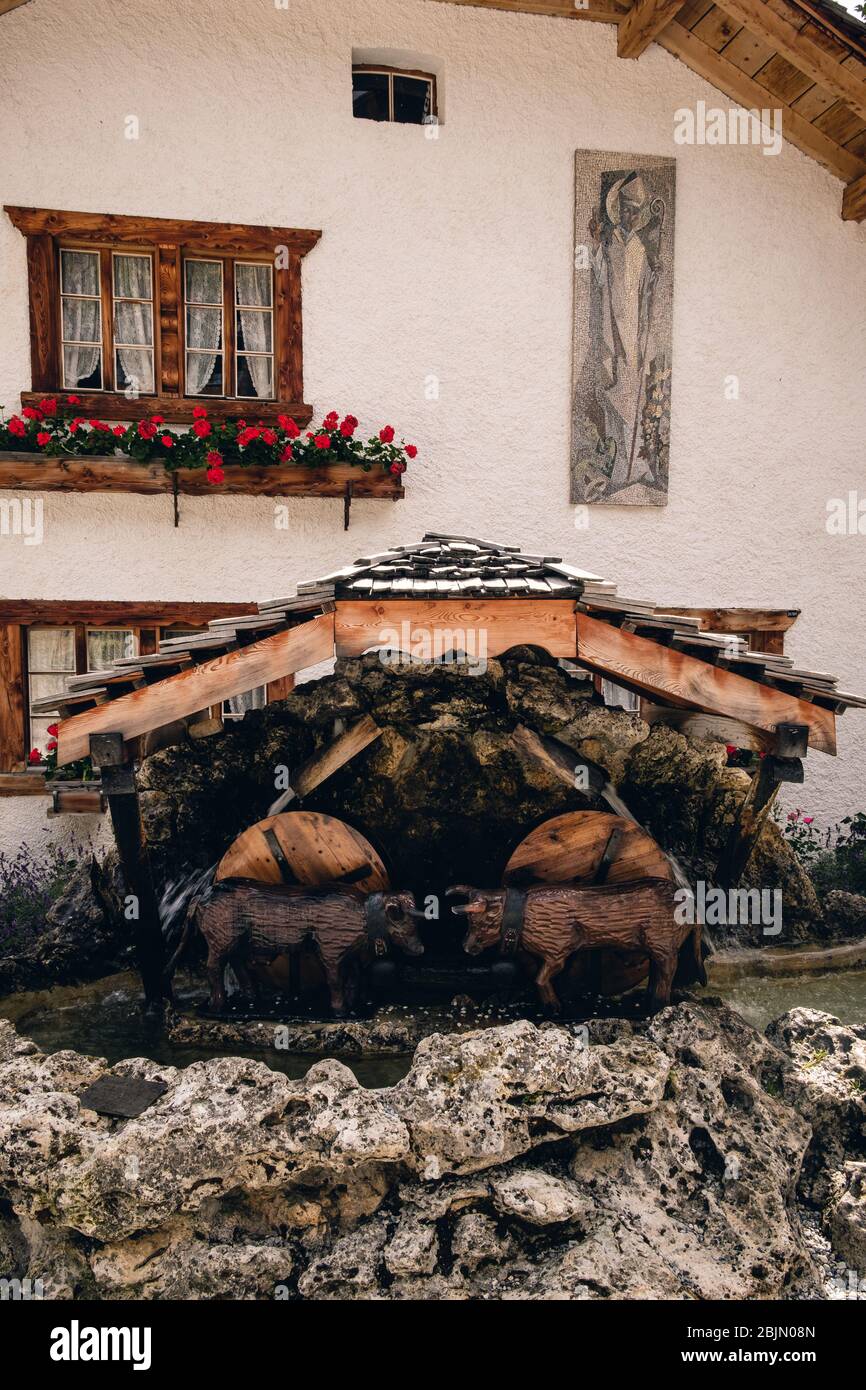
[656,19,866,183]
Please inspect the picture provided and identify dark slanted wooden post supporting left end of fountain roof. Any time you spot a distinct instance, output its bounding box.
[90,734,168,1009]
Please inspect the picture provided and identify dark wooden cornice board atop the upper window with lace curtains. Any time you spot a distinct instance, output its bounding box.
[4,203,321,256]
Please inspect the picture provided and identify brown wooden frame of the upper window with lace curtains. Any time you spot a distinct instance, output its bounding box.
[6,206,321,425]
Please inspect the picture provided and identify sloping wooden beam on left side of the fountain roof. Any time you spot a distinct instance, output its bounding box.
[57,613,334,766]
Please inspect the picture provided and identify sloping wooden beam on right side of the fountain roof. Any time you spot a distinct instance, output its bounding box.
[578,613,835,753]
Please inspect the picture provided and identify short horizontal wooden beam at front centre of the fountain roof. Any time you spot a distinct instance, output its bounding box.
[335,598,575,662]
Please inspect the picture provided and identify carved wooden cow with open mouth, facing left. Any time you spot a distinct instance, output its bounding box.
[448,878,706,1012]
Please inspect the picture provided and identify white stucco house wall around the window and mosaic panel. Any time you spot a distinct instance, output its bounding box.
[0,0,866,841]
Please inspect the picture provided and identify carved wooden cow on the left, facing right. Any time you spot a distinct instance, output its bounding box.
[170,878,424,1017]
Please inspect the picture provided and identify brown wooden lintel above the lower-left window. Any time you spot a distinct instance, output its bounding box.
[0,598,259,627]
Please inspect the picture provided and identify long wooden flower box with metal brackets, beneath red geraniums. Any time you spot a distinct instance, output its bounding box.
[0,452,405,530]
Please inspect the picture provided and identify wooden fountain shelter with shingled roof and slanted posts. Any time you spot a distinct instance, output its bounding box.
[40,532,866,999]
